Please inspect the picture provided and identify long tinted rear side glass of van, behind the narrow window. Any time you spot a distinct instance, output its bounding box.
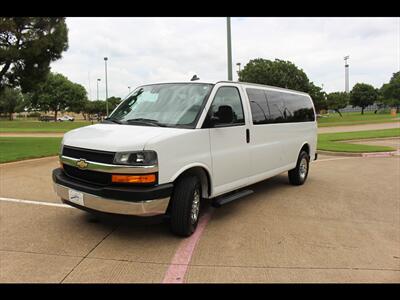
[267,91,315,123]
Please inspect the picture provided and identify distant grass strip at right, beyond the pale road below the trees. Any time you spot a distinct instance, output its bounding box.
[318,111,400,127]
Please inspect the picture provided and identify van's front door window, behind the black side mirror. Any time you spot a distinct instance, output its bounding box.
[203,86,244,127]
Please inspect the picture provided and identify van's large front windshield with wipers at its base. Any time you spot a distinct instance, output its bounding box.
[107,83,213,128]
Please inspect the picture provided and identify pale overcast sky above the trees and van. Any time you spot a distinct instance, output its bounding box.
[51,17,400,99]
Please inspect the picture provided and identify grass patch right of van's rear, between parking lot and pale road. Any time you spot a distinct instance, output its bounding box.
[317,128,400,153]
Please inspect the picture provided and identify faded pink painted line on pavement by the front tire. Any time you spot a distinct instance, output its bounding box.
[163,208,213,283]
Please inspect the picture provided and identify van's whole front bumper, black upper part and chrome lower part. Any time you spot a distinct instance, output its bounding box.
[53,169,173,216]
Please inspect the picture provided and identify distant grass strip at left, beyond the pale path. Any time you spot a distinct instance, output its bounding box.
[0,120,92,132]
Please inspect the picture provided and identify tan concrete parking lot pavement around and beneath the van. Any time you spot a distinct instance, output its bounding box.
[0,155,400,283]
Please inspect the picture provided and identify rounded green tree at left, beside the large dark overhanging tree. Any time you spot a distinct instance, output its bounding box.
[31,73,87,120]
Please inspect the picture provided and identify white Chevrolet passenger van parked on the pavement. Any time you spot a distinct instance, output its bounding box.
[53,81,317,236]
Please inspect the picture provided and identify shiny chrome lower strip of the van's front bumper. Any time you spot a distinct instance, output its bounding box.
[54,183,170,216]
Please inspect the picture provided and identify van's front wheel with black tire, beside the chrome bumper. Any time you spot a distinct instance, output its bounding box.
[170,176,201,237]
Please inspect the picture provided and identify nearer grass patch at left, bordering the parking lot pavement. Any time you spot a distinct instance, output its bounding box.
[0,137,61,163]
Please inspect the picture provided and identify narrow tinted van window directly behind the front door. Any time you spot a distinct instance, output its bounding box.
[246,89,269,125]
